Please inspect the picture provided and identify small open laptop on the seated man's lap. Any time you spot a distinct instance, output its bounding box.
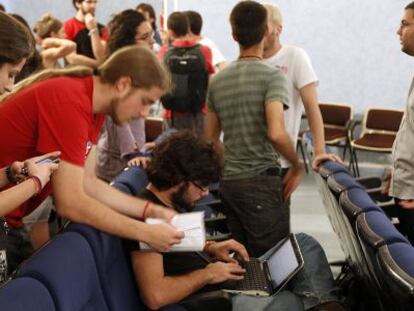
[201,234,304,296]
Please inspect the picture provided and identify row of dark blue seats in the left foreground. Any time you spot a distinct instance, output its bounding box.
[0,167,231,311]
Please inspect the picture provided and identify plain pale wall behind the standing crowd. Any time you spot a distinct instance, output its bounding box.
[0,0,414,112]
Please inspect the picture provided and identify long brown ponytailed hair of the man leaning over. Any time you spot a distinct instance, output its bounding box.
[1,46,170,102]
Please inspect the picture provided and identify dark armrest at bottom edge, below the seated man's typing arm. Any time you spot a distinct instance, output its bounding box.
[179,290,232,311]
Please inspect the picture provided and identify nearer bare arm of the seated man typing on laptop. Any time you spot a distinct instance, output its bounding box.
[131,252,245,309]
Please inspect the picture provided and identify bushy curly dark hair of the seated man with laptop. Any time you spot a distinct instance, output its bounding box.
[147,131,222,190]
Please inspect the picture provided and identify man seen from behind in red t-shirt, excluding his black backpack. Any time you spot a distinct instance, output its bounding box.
[158,12,214,136]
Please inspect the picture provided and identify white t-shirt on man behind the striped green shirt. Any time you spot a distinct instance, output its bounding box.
[264,45,318,167]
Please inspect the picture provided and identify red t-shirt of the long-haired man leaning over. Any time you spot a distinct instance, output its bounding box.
[0,77,104,227]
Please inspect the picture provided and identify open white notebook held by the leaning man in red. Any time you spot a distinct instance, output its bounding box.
[139,212,206,252]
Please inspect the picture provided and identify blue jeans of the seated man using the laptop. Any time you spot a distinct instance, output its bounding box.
[232,233,341,311]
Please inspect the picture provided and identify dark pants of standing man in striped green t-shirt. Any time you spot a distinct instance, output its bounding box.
[220,175,290,257]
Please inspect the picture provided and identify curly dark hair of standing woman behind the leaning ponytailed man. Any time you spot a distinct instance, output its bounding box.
[107,9,146,55]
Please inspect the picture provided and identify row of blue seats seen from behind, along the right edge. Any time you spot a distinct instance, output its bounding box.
[315,161,414,310]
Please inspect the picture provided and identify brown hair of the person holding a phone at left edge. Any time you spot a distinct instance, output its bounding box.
[0,12,34,66]
